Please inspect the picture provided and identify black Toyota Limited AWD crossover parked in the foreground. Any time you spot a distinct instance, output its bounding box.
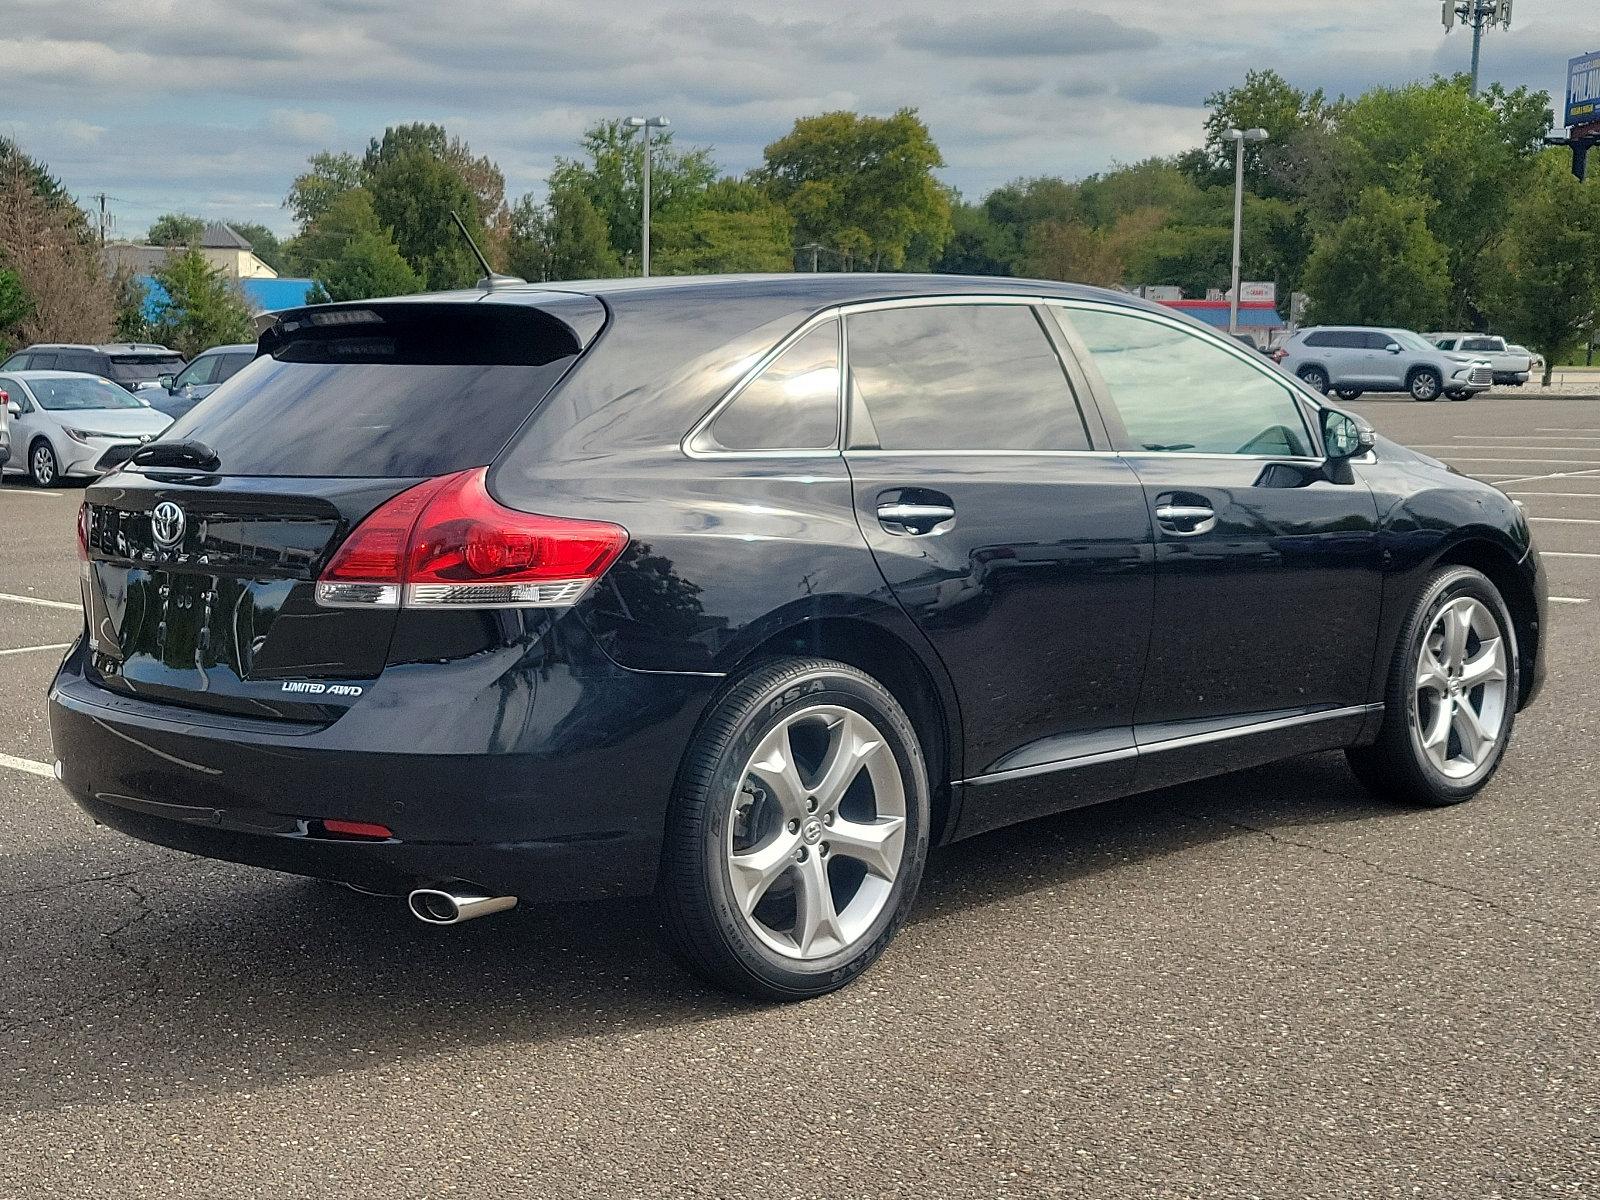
[50,275,1546,998]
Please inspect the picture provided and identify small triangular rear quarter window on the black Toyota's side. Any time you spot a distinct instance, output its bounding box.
[710,322,838,450]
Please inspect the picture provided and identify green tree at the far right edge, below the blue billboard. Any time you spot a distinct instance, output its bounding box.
[1490,150,1600,384]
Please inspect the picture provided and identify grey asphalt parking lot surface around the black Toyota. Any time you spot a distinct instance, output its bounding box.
[0,394,1600,1200]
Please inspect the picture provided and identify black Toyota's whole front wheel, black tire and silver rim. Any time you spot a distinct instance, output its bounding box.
[1346,566,1518,806]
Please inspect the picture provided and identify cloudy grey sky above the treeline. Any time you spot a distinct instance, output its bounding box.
[0,0,1600,237]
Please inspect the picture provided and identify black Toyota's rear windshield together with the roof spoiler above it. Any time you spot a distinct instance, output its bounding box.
[156,304,579,477]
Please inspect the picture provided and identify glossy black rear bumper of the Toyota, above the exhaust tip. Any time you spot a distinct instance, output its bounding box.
[50,618,718,901]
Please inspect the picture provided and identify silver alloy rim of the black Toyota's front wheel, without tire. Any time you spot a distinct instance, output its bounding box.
[1411,595,1507,781]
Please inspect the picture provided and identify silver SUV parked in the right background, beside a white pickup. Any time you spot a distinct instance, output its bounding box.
[1272,325,1494,400]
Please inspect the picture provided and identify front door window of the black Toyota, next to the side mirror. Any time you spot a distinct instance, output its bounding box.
[1064,309,1312,458]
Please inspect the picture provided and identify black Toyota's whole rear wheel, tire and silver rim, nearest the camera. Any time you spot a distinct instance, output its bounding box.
[658,658,930,1000]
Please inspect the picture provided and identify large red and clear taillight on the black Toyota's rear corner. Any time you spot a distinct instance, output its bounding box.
[317,467,627,608]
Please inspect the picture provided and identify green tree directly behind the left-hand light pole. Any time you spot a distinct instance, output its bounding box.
[550,120,717,261]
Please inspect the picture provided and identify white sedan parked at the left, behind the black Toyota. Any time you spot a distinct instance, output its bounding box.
[0,371,173,488]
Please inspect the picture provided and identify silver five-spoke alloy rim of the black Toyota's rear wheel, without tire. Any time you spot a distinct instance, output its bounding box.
[726,704,906,960]
